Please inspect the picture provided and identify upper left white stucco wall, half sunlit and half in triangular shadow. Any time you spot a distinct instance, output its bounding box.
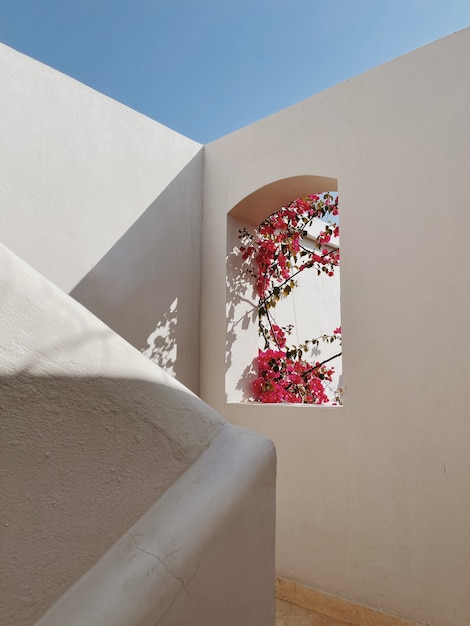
[0,45,203,391]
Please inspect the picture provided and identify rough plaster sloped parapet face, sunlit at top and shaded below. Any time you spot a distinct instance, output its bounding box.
[0,247,226,626]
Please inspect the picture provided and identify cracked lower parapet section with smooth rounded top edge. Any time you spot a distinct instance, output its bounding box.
[36,426,275,626]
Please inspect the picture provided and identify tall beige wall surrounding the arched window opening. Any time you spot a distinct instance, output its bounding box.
[201,30,470,626]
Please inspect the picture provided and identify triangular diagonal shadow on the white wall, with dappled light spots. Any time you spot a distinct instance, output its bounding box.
[70,150,203,393]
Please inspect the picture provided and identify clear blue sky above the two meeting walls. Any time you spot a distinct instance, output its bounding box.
[0,0,470,143]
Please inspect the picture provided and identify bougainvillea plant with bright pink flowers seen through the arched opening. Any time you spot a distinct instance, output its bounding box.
[239,193,342,404]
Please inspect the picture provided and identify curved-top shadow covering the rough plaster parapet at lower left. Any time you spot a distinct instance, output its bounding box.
[0,372,220,625]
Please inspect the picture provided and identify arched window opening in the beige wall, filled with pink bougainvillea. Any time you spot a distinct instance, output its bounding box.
[226,177,342,406]
